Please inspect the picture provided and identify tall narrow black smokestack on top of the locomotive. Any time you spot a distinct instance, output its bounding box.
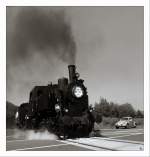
[68,65,76,83]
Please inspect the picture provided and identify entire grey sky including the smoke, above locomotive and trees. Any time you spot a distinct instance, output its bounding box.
[6,6,144,110]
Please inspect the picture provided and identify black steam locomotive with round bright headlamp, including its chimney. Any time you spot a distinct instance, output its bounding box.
[16,65,95,139]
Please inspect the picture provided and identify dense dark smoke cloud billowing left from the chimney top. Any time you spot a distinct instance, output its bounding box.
[9,7,76,64]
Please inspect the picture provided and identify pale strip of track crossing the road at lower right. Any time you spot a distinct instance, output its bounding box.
[67,137,144,151]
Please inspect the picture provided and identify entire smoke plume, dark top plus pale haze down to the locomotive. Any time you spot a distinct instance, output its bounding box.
[6,7,76,105]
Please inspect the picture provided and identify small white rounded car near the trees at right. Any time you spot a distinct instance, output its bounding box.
[115,117,136,129]
